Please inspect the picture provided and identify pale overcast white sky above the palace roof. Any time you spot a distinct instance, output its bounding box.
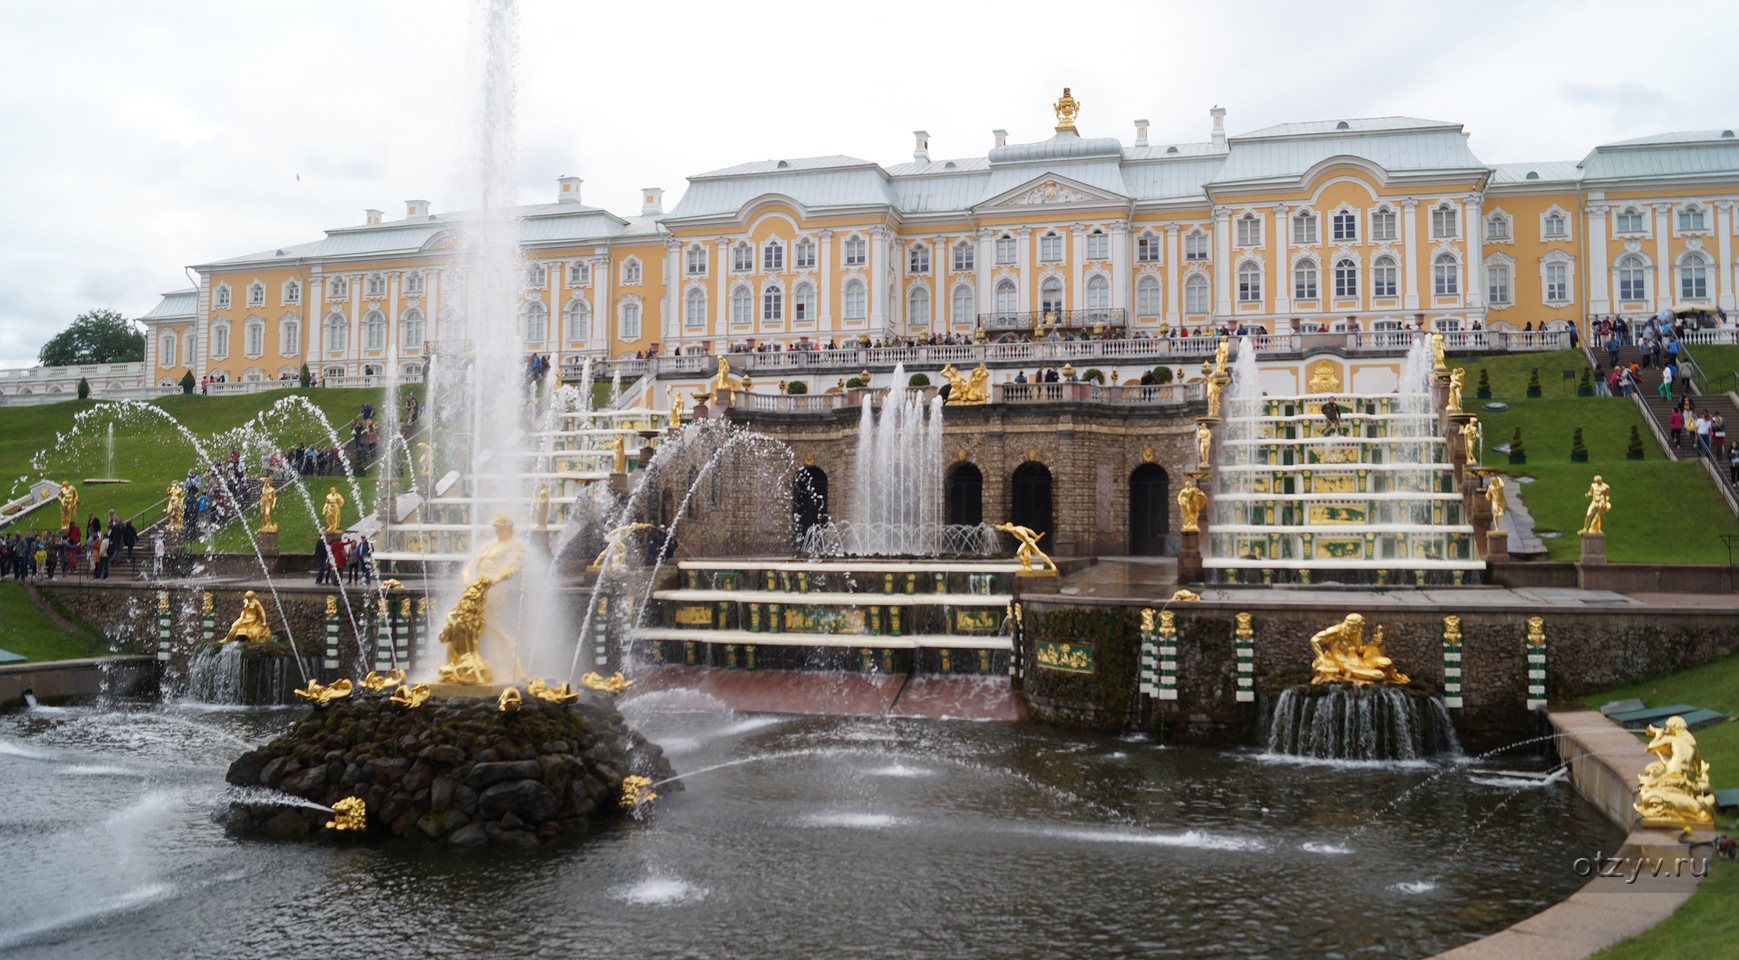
[0,0,1739,367]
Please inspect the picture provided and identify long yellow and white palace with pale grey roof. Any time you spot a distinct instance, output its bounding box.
[144,92,1739,386]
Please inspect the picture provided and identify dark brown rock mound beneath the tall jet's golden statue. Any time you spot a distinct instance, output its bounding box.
[223,690,682,847]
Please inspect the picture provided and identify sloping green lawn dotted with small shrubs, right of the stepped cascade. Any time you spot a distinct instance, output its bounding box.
[1452,350,1739,563]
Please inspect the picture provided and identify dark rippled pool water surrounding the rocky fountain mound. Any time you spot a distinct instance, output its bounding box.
[0,697,1619,960]
